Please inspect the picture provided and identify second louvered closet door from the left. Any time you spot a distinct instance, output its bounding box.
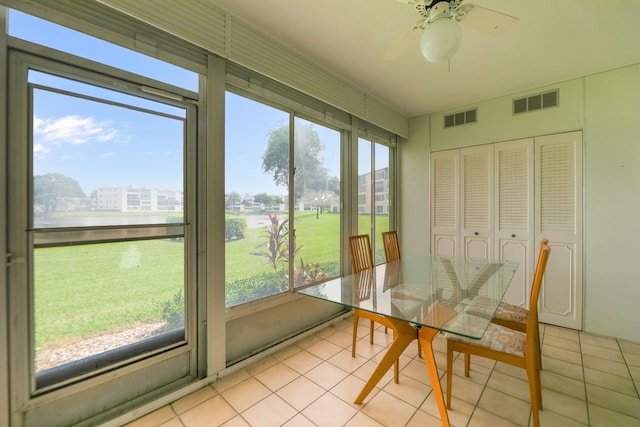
[460,145,493,258]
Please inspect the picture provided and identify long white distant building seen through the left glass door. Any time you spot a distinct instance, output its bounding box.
[94,187,184,212]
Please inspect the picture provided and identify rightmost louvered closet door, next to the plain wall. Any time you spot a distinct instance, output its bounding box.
[535,132,582,329]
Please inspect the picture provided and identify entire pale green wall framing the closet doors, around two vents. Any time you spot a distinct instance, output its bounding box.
[399,64,640,341]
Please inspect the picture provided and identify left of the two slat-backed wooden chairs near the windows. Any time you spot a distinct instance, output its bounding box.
[349,234,399,383]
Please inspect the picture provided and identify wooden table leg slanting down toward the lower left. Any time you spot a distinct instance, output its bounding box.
[354,317,418,405]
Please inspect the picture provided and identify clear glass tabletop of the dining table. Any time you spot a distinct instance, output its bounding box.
[298,255,518,339]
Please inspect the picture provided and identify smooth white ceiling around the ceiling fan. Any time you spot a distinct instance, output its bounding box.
[212,0,640,117]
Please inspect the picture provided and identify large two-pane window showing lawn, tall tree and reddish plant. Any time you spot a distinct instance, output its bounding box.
[225,92,341,307]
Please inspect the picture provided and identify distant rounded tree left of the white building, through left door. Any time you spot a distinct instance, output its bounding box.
[33,173,87,213]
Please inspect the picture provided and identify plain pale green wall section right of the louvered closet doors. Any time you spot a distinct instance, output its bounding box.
[584,64,640,341]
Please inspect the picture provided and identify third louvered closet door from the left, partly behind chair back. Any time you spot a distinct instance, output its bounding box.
[494,138,537,308]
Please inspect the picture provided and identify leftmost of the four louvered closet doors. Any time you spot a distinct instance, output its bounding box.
[431,150,460,255]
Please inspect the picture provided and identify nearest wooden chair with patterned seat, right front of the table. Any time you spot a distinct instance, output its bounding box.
[445,239,550,427]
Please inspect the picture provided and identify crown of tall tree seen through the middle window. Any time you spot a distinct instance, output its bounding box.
[262,123,328,199]
